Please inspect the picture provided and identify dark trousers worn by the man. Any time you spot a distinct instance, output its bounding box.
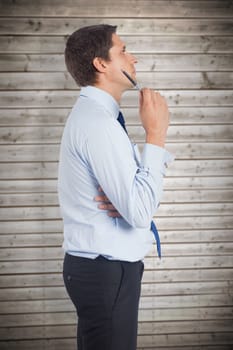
[63,254,144,350]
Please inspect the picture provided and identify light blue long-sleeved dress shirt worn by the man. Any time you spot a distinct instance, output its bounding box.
[58,86,172,261]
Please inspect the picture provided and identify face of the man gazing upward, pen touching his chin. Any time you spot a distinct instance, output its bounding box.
[106,33,137,89]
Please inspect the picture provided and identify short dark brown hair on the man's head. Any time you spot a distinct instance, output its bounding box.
[65,24,117,86]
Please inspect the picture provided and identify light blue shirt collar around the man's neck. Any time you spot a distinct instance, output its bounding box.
[80,86,119,119]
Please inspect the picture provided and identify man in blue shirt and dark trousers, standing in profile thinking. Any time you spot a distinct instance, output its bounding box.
[58,25,170,350]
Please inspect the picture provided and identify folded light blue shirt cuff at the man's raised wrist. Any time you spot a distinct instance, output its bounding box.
[141,143,175,175]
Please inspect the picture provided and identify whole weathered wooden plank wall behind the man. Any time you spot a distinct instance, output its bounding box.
[0,0,233,350]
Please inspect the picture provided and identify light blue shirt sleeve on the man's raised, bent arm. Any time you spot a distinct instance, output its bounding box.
[84,117,172,228]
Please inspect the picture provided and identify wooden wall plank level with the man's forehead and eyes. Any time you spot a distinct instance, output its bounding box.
[0,34,233,55]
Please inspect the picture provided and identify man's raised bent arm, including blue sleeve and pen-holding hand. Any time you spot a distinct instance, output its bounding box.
[86,89,172,228]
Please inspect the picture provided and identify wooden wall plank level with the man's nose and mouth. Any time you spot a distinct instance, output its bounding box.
[0,53,233,72]
